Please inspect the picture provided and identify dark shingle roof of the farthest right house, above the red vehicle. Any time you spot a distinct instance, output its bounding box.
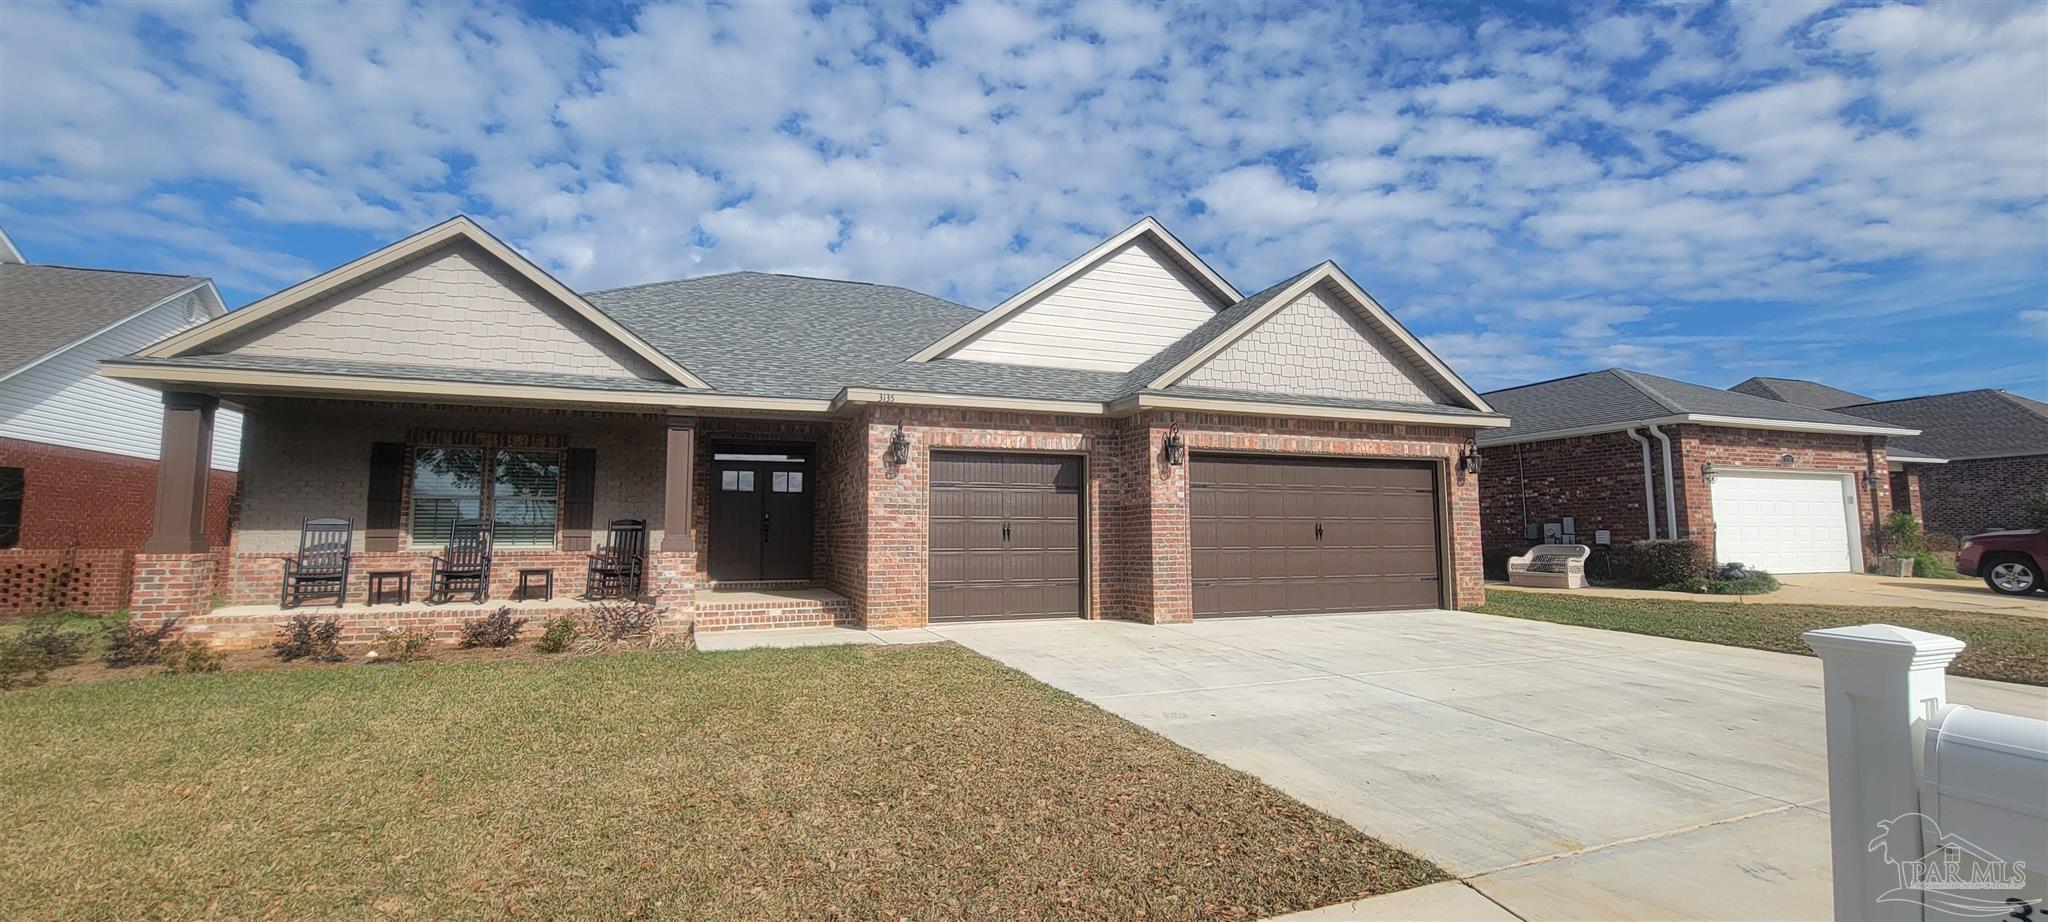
[1841,387,2048,461]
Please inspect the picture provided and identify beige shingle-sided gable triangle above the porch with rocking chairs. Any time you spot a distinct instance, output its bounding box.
[205,244,666,379]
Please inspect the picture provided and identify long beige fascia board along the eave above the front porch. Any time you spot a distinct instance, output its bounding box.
[100,363,831,414]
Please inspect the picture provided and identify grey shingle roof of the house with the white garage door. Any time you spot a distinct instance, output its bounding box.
[1479,369,1915,445]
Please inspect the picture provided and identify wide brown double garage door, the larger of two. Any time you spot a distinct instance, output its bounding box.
[1188,455,1442,617]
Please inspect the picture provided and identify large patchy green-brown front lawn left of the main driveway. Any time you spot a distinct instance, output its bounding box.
[0,645,1446,920]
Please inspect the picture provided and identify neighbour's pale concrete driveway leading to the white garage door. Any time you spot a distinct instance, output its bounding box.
[1487,574,2048,619]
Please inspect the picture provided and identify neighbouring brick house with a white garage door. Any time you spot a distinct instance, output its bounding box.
[1477,369,1917,574]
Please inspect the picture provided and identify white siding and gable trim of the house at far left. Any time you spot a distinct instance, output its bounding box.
[0,291,242,471]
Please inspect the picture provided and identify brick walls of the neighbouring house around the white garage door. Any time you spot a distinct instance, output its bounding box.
[1481,424,1892,561]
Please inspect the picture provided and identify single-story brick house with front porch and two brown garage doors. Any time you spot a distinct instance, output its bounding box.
[102,217,1507,643]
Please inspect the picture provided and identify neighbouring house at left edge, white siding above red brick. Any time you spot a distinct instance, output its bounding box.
[0,226,240,615]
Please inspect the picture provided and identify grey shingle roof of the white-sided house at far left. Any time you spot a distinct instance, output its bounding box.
[0,262,205,375]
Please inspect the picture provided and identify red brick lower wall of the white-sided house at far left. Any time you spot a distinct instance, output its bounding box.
[0,438,236,551]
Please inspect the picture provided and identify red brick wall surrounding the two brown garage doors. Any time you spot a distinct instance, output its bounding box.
[860,408,1485,627]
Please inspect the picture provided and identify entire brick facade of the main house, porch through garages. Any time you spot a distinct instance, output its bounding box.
[137,400,1485,637]
